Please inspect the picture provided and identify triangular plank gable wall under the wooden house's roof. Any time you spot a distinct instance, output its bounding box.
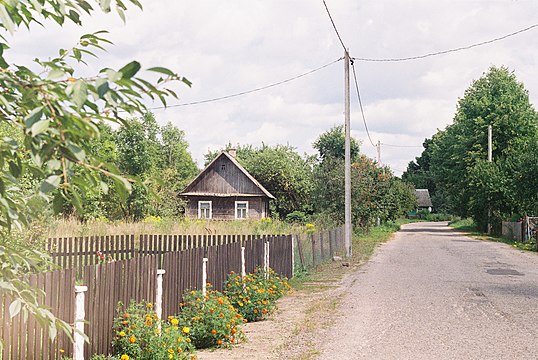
[188,156,264,195]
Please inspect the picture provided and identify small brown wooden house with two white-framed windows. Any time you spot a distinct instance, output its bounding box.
[180,150,275,220]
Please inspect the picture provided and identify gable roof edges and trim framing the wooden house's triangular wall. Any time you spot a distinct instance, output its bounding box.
[180,151,275,199]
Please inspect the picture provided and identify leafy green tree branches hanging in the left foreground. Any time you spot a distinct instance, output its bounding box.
[0,0,190,344]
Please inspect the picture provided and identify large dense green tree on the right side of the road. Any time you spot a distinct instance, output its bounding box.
[403,67,538,231]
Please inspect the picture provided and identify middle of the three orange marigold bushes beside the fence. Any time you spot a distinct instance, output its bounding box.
[180,284,243,349]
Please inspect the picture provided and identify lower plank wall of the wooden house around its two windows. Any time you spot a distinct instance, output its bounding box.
[185,196,269,220]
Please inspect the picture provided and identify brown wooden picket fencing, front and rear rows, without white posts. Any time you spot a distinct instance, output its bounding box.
[0,235,293,360]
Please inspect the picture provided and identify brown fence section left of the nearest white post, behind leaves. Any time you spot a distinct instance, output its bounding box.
[0,269,75,360]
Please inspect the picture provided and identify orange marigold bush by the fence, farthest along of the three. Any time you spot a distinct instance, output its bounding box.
[224,268,290,321]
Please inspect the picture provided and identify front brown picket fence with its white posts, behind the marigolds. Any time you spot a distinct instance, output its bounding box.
[0,236,293,360]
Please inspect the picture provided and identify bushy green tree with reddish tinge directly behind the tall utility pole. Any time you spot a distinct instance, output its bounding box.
[312,127,416,228]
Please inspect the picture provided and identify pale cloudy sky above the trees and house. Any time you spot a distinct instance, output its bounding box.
[4,0,538,176]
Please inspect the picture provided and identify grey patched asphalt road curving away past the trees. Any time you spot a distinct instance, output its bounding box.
[319,223,538,360]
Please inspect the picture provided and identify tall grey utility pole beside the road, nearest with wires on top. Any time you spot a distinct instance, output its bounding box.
[344,49,352,258]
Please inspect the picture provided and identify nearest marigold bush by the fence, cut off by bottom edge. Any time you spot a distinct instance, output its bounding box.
[112,301,194,360]
